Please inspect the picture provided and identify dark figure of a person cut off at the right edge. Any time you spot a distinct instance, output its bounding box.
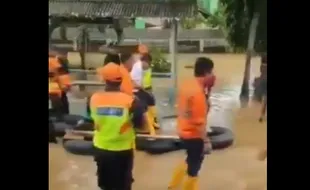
[259,54,267,122]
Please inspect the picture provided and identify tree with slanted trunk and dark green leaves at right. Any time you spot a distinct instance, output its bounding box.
[221,0,267,103]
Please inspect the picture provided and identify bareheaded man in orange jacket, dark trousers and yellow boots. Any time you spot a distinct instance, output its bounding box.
[168,57,213,190]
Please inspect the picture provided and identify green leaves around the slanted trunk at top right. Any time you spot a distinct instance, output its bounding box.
[181,0,267,52]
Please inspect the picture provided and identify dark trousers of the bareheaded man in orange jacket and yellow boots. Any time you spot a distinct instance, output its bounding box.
[182,138,204,177]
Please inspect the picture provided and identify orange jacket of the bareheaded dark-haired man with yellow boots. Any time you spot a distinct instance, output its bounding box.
[177,78,208,139]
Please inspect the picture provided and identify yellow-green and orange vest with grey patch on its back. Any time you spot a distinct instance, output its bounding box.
[90,92,135,151]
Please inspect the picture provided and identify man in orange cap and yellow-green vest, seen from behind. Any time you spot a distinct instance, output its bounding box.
[89,63,144,190]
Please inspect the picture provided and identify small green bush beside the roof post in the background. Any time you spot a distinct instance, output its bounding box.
[150,48,171,73]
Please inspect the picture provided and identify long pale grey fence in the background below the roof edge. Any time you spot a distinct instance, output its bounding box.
[52,27,228,53]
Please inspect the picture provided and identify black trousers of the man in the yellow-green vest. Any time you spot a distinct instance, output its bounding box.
[95,148,134,190]
